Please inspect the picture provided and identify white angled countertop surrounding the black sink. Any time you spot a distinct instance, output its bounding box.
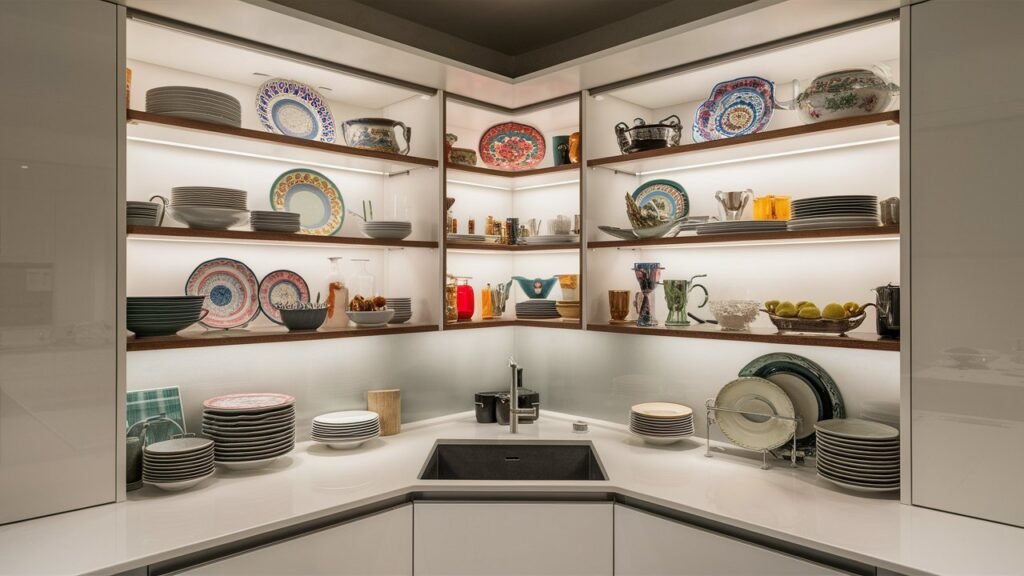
[0,411,1024,576]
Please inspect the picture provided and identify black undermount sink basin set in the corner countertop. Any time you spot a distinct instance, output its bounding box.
[420,440,607,481]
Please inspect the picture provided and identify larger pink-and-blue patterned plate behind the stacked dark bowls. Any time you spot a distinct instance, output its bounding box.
[185,258,259,330]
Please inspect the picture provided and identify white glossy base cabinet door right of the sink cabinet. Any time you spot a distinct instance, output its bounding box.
[615,505,843,576]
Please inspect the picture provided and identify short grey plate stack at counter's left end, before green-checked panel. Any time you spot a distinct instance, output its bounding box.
[142,438,214,491]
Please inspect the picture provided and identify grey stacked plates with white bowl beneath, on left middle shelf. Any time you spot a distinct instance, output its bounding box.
[170,186,249,230]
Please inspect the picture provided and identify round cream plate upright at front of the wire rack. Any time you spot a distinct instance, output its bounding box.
[715,377,797,450]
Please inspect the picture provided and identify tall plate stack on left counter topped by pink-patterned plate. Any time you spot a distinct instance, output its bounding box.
[203,393,295,469]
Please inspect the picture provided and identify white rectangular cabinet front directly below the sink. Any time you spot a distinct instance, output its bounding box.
[414,502,612,576]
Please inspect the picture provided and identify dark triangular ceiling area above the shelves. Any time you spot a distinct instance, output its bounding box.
[264,0,758,78]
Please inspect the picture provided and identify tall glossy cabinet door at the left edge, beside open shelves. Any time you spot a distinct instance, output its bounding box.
[0,0,121,524]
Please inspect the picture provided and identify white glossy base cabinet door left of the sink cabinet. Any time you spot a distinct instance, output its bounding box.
[179,504,413,576]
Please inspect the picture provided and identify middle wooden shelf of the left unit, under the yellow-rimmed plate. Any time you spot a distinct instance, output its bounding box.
[127,225,438,248]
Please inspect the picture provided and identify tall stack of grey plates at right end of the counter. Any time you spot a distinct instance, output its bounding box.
[814,418,899,492]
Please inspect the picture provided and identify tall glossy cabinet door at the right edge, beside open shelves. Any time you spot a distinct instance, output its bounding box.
[908,0,1024,526]
